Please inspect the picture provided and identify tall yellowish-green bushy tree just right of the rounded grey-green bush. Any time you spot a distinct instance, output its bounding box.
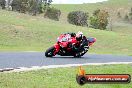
[90,9,109,30]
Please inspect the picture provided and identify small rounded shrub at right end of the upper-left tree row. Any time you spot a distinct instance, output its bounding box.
[44,7,61,21]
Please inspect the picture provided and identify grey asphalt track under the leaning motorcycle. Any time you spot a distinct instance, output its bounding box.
[0,52,132,69]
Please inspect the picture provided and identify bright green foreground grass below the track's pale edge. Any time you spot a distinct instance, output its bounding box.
[0,64,132,88]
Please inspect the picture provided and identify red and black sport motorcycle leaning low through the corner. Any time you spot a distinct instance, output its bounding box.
[45,34,96,57]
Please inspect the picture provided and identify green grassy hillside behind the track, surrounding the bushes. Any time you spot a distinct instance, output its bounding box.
[0,0,132,55]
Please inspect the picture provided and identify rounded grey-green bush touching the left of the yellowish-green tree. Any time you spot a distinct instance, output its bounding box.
[67,11,88,26]
